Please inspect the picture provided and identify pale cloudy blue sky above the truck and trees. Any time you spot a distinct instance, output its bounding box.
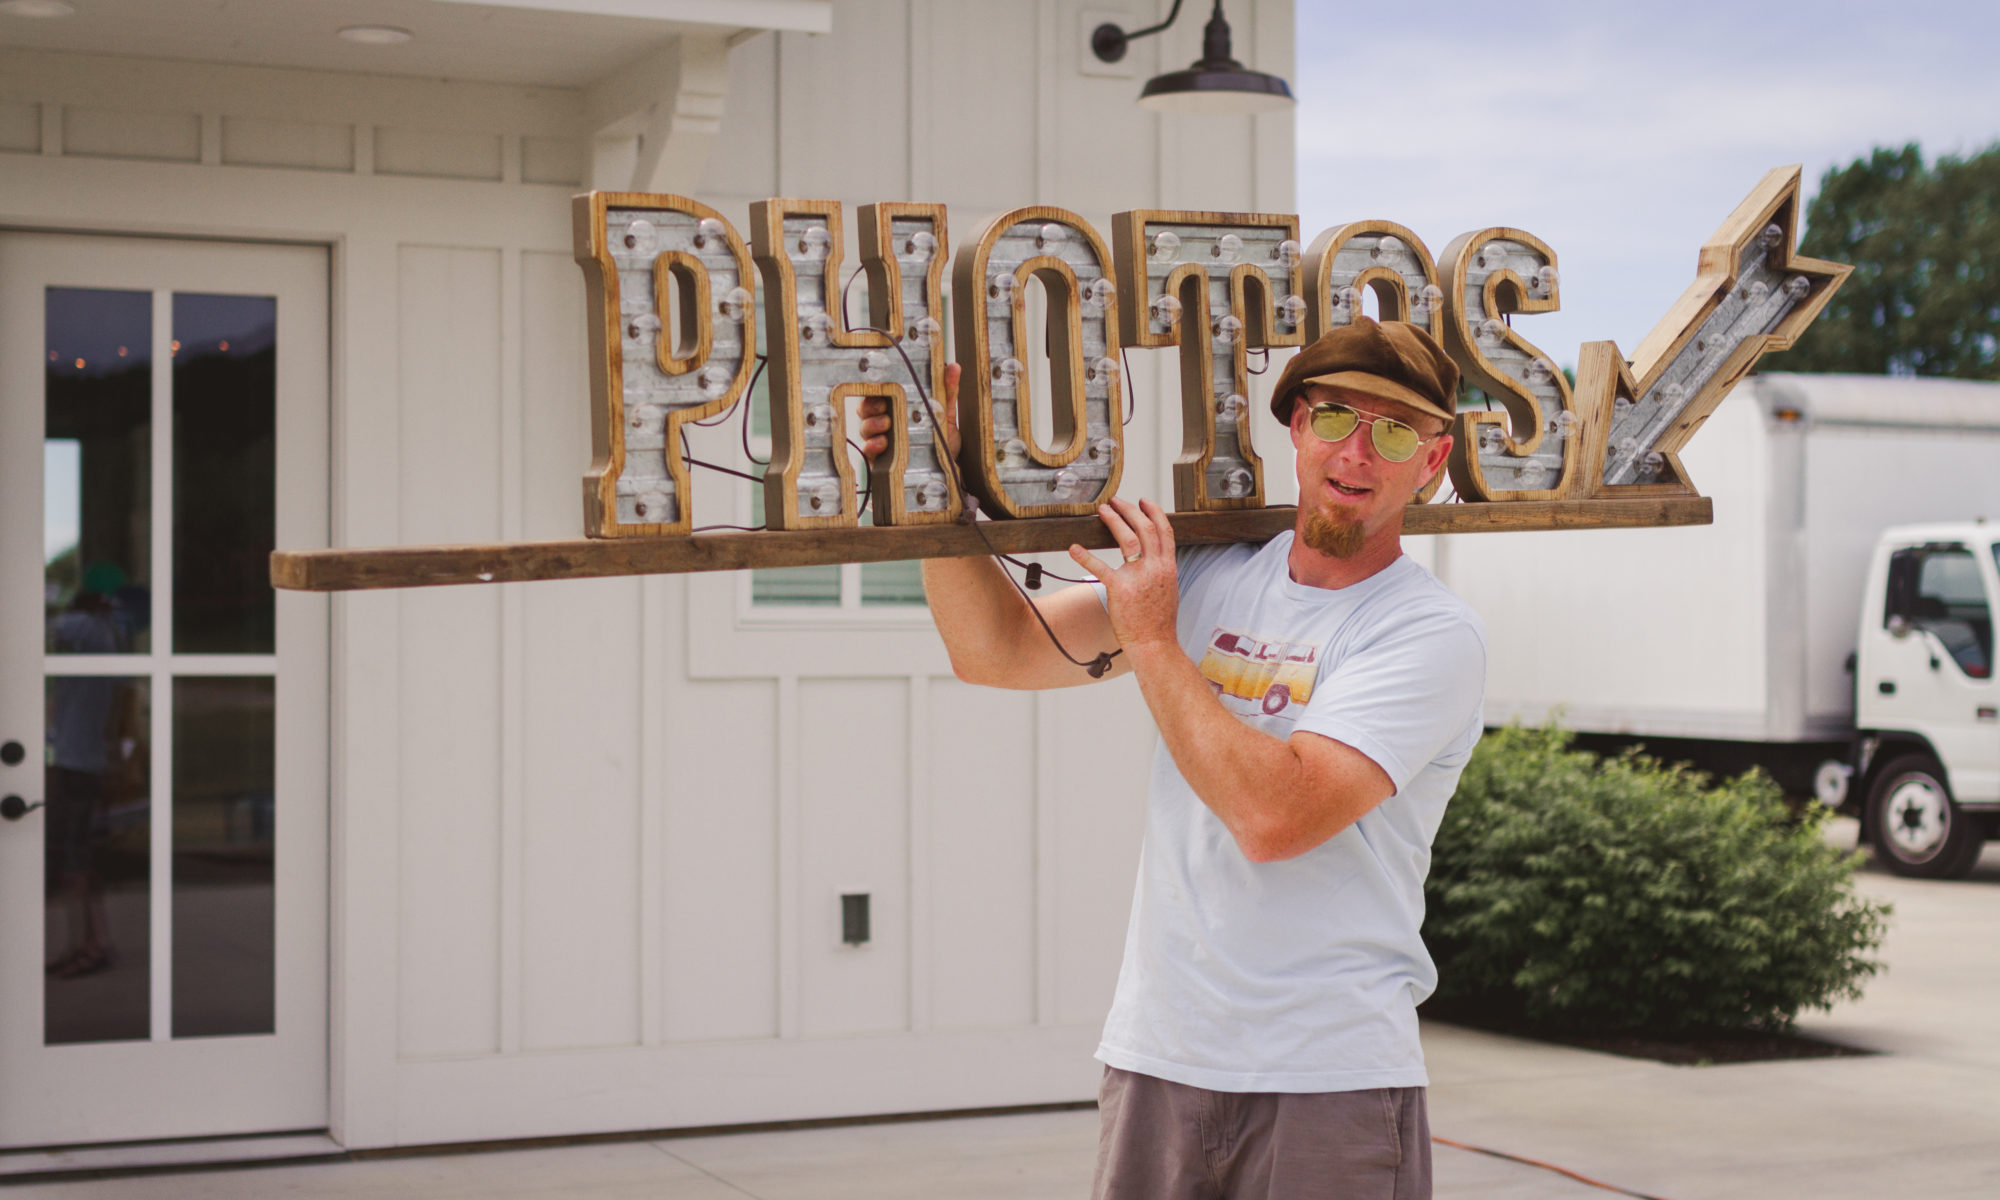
[1292,0,2000,364]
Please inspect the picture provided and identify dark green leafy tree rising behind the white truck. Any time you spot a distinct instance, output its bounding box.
[1768,142,2000,380]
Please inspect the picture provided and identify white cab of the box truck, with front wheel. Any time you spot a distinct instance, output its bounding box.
[1848,522,2000,878]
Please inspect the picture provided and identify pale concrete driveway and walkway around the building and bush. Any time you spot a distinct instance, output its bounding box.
[10,822,2000,1200]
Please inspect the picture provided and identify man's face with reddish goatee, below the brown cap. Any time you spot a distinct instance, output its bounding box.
[1292,384,1452,558]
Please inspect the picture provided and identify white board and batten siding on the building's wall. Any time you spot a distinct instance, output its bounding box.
[0,0,1294,1148]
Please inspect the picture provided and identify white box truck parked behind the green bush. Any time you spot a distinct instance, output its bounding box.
[1434,374,2000,876]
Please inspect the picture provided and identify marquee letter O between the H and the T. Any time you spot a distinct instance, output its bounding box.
[952,206,1124,516]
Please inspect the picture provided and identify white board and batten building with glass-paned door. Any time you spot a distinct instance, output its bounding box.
[0,0,1310,1148]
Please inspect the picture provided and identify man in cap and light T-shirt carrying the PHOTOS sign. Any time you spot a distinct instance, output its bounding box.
[862,318,1486,1200]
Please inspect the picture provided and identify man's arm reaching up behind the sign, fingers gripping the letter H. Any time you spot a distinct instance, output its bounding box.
[862,362,1130,688]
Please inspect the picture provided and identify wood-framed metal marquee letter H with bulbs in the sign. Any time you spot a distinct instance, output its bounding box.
[750,200,960,530]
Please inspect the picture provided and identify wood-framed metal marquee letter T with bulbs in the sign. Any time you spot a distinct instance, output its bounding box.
[1112,208,1306,512]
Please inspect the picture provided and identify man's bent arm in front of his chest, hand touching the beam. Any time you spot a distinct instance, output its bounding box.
[1070,500,1396,862]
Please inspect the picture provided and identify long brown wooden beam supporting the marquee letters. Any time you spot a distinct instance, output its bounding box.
[270,496,1714,592]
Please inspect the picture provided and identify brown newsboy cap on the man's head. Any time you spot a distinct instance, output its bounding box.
[1270,316,1458,424]
